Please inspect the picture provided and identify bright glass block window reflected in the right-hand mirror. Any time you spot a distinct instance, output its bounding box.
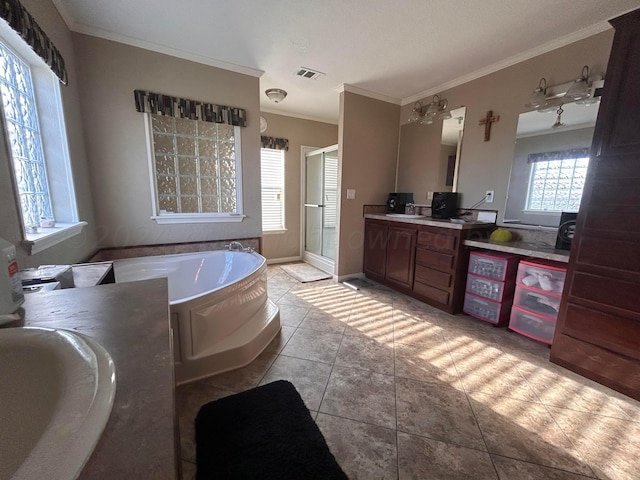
[527,157,589,212]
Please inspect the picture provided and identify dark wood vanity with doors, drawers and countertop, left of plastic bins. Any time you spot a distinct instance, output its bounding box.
[363,214,495,313]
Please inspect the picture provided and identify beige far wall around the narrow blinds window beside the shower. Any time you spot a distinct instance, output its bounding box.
[262,112,338,260]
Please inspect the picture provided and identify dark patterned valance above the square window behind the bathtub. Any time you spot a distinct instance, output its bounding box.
[133,90,247,127]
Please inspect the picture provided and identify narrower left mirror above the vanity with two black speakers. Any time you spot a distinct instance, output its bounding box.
[397,107,466,199]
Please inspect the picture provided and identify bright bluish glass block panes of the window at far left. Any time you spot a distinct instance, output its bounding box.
[0,43,53,227]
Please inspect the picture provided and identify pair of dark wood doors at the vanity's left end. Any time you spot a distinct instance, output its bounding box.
[363,219,418,290]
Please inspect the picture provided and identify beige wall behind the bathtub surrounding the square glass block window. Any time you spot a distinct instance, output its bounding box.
[73,34,262,247]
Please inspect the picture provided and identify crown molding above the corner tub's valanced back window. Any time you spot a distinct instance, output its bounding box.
[68,21,264,78]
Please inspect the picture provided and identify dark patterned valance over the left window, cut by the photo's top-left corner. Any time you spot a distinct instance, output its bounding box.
[0,0,68,85]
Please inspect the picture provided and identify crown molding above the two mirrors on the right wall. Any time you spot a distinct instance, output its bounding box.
[401,21,612,106]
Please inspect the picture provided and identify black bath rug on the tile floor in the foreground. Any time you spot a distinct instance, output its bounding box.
[196,380,348,480]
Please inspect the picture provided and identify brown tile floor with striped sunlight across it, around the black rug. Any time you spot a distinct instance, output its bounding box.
[177,266,640,480]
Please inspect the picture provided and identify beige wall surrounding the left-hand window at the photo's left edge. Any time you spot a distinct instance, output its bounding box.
[0,0,97,268]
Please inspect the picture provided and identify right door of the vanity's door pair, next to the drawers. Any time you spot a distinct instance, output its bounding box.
[387,226,418,288]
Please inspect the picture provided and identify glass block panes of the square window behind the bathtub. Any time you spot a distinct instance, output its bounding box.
[149,114,241,216]
